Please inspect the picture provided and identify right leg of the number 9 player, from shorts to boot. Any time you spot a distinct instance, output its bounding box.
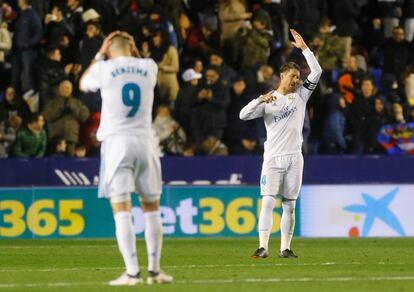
[135,146,173,284]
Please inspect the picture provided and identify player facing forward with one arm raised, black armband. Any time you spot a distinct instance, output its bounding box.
[240,29,322,258]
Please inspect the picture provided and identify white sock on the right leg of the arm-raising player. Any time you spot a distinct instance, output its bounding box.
[280,200,296,251]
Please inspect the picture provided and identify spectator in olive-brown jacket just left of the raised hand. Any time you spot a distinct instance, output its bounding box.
[242,13,272,69]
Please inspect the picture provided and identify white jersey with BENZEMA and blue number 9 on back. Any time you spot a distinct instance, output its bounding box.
[81,57,158,141]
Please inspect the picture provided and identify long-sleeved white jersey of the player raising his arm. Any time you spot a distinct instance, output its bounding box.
[240,49,322,160]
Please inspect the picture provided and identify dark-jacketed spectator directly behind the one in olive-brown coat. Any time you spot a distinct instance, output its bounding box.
[37,47,70,109]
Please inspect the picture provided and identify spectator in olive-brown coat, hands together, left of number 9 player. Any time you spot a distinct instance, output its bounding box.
[43,80,89,156]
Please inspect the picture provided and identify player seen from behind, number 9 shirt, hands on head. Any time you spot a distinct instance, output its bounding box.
[80,31,173,286]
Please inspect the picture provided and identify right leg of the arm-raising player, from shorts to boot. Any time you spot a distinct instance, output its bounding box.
[279,154,303,258]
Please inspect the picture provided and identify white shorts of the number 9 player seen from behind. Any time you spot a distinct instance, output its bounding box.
[98,136,162,202]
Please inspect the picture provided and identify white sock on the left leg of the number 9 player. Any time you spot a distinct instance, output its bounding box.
[114,211,139,275]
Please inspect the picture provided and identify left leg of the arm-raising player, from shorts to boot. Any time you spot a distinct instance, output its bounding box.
[252,160,284,258]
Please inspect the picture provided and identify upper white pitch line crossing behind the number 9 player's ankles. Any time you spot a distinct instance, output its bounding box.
[0,262,404,273]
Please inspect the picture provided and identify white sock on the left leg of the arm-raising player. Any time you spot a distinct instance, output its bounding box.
[259,196,276,250]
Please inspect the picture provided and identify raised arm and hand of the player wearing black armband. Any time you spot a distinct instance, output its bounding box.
[290,29,322,99]
